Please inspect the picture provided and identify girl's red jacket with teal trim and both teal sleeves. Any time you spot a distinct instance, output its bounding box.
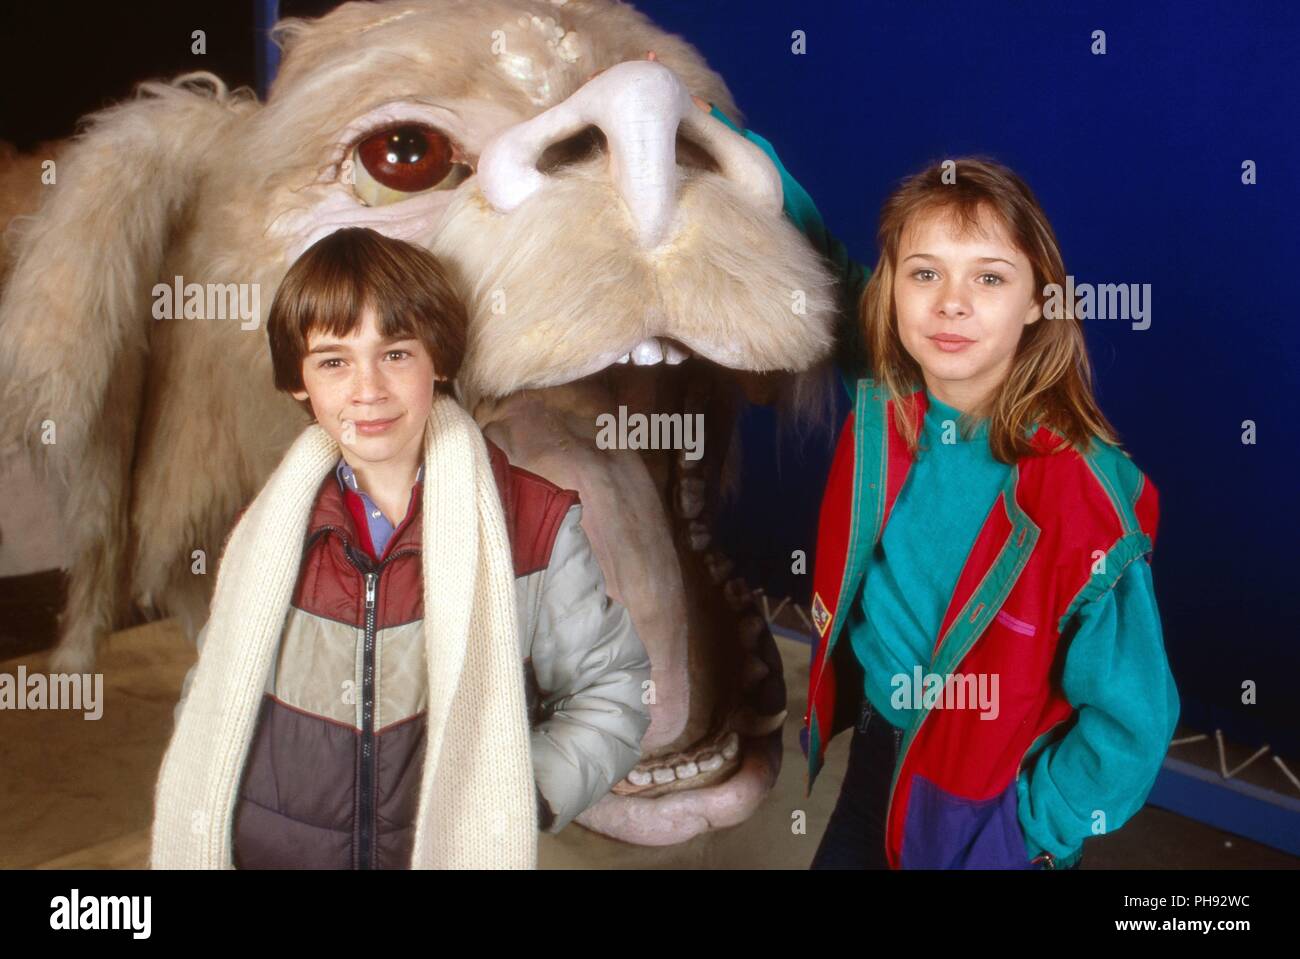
[712,100,1179,868]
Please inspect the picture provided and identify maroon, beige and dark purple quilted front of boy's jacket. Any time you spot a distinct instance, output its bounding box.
[234,441,577,869]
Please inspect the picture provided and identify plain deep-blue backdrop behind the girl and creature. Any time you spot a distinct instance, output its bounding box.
[621,0,1300,756]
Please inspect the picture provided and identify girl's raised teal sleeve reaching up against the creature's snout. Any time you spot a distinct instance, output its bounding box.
[711,107,871,396]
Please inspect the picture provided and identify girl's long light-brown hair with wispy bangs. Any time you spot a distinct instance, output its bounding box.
[858,157,1118,463]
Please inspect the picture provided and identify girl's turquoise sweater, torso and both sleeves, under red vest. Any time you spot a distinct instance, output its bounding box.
[712,108,1179,865]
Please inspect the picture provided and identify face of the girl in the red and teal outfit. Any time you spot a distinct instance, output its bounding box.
[893,207,1041,411]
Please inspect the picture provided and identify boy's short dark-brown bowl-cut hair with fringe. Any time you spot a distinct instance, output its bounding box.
[267,226,469,415]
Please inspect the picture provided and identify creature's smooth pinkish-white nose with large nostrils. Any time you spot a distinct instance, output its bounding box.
[478,60,781,248]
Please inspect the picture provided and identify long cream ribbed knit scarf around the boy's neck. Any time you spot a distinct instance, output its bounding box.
[150,395,537,869]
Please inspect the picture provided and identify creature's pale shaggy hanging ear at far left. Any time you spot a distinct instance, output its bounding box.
[0,73,256,459]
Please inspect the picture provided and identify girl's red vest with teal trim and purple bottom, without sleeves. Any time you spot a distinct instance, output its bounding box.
[803,378,1158,868]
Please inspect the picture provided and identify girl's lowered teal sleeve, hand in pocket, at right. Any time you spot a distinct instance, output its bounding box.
[1017,559,1179,865]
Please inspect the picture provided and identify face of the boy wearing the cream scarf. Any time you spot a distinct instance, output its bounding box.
[293,307,446,465]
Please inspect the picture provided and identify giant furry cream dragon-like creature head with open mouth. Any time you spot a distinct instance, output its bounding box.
[0,0,835,843]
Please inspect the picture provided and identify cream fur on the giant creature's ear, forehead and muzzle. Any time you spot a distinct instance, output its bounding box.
[0,0,831,671]
